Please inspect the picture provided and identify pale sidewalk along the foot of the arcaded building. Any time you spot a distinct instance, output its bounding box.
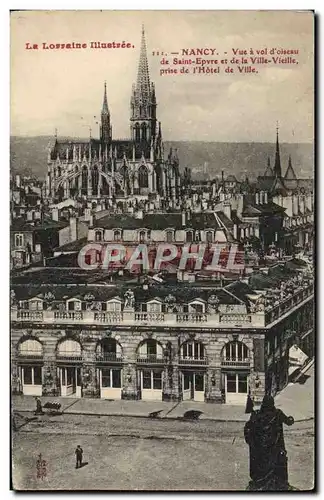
[12,367,314,422]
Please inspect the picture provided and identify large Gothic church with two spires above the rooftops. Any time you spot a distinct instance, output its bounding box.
[46,28,180,206]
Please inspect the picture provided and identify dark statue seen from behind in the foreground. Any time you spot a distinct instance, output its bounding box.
[244,395,294,491]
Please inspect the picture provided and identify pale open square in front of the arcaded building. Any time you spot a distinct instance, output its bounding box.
[13,415,314,490]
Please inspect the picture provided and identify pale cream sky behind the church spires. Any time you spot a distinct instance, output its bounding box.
[10,11,314,143]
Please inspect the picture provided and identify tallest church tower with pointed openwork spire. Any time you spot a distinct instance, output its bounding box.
[130,27,157,144]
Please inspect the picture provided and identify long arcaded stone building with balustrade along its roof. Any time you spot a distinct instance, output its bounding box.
[11,264,314,405]
